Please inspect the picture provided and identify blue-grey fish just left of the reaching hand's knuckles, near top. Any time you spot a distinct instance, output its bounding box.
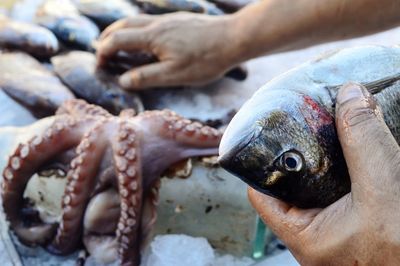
[35,0,100,50]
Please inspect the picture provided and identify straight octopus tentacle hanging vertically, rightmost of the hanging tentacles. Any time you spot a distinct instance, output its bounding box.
[113,122,142,265]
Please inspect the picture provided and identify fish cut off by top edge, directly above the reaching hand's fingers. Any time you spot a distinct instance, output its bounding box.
[75,0,140,29]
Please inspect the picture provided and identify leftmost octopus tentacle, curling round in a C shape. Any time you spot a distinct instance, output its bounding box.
[2,117,90,245]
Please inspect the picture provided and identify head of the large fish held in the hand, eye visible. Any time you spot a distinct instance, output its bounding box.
[219,90,349,208]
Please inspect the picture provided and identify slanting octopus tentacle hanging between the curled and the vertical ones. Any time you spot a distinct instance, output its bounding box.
[47,120,107,254]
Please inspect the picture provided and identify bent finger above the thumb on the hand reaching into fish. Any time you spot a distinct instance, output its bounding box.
[97,29,151,65]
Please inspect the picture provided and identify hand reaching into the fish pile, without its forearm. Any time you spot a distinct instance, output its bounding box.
[97,12,241,89]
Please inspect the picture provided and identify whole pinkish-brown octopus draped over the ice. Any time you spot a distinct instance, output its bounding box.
[1,99,221,265]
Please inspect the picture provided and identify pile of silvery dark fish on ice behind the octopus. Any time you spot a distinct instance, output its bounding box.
[0,0,254,121]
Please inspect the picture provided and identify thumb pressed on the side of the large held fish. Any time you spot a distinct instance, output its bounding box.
[336,83,400,186]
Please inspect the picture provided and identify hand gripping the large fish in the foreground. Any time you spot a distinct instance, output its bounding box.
[249,83,400,265]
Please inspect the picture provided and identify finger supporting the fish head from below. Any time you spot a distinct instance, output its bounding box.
[248,187,321,244]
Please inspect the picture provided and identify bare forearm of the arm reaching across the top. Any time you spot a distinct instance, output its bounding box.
[229,0,400,63]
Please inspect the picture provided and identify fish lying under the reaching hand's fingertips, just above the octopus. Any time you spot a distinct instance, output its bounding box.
[51,51,143,114]
